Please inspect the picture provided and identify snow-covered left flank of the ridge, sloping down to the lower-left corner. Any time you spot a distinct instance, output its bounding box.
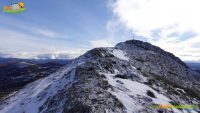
[0,60,78,113]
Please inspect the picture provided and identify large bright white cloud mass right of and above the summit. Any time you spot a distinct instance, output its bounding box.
[111,0,200,61]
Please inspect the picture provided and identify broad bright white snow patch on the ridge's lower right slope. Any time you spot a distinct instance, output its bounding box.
[100,70,196,113]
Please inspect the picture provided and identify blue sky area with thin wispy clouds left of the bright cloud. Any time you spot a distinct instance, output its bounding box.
[0,0,126,52]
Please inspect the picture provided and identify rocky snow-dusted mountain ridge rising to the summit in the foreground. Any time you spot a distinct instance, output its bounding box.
[0,40,200,113]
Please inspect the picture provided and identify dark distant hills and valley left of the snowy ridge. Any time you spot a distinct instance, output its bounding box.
[0,58,70,98]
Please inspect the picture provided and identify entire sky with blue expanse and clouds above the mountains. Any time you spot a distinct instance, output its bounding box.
[0,0,200,61]
